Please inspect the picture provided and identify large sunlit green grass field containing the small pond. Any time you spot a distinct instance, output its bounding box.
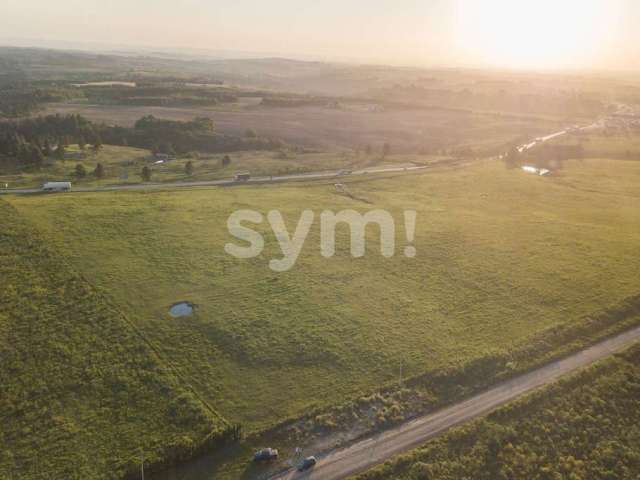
[10,156,640,440]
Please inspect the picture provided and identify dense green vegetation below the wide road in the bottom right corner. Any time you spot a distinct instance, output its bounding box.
[357,346,640,480]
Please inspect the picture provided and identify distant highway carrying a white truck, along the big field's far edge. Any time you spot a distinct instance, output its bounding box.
[0,164,430,194]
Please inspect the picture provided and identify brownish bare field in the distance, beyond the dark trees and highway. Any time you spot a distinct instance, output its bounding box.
[45,103,563,151]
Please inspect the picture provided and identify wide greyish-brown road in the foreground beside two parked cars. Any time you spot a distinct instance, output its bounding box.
[272,327,640,480]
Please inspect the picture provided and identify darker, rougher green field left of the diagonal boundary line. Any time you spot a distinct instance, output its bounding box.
[0,200,226,479]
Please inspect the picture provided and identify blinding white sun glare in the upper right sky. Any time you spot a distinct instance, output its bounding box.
[457,0,618,68]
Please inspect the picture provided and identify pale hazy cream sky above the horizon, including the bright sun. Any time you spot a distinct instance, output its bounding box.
[0,0,640,69]
